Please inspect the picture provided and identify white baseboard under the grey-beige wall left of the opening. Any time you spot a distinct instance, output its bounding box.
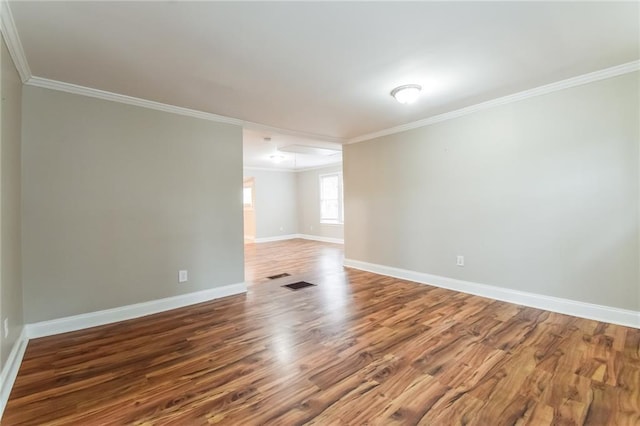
[25,283,247,339]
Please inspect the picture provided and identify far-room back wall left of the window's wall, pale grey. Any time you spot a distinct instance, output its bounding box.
[244,168,298,239]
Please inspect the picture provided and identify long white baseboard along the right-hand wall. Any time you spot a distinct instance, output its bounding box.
[344,259,640,328]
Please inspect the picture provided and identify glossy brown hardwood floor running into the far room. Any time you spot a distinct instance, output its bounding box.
[2,240,640,426]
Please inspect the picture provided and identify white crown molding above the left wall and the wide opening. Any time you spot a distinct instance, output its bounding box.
[25,77,346,144]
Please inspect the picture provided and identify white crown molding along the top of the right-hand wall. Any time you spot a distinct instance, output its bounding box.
[347,61,640,144]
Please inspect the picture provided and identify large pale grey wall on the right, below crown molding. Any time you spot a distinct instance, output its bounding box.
[344,72,640,310]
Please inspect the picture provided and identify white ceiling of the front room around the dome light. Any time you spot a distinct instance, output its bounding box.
[10,1,640,170]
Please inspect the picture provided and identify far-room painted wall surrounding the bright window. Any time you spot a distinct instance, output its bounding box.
[296,164,344,239]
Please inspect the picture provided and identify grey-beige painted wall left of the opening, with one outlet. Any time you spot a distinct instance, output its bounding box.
[22,86,244,323]
